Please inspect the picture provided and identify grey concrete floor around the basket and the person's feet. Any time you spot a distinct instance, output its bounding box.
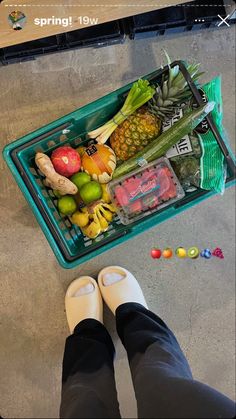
[0,28,235,418]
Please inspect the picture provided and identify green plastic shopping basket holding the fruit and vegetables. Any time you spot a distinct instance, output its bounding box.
[3,61,235,268]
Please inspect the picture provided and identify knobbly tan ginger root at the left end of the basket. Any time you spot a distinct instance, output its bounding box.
[35,153,78,195]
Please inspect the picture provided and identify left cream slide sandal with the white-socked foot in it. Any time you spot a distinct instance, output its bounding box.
[65,276,103,333]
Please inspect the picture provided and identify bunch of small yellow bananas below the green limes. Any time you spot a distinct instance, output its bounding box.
[71,200,116,239]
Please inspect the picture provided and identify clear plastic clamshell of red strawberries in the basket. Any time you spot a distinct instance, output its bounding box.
[108,158,185,225]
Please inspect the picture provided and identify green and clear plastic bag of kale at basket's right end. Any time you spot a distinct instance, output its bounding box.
[164,77,226,194]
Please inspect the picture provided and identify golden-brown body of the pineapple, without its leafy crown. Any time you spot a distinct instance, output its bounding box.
[110,106,161,161]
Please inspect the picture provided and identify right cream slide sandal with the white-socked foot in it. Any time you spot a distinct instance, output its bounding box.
[98,266,148,314]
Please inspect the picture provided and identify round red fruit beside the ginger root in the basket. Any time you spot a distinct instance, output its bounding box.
[51,146,81,177]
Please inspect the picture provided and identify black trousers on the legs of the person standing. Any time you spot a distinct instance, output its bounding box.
[60,303,235,419]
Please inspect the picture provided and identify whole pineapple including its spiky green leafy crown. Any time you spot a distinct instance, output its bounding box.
[110,52,202,161]
